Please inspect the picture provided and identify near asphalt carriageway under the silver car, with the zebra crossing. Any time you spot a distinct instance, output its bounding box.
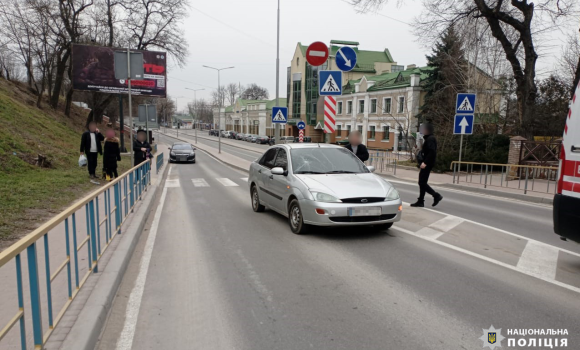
[98,152,580,350]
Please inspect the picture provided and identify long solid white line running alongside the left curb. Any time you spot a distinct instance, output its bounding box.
[117,189,171,350]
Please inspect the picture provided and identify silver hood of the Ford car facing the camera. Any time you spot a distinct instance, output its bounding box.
[296,173,392,199]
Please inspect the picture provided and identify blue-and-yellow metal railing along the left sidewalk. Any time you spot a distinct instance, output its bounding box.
[0,161,151,350]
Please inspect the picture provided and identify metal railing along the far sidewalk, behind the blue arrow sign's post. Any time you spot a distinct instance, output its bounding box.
[451,161,558,194]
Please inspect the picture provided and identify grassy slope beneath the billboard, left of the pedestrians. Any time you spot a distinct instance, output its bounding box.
[0,79,129,241]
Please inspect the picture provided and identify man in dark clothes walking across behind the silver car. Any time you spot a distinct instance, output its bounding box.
[411,123,443,207]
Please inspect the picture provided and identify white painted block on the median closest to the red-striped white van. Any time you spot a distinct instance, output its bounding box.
[518,241,559,279]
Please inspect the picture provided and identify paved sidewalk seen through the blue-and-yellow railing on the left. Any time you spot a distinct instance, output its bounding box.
[0,145,169,350]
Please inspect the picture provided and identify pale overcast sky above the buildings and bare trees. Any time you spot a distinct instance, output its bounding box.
[168,0,576,109]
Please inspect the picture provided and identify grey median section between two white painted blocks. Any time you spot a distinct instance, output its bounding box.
[438,222,527,266]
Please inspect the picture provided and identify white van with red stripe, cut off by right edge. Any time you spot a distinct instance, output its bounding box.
[554,80,580,243]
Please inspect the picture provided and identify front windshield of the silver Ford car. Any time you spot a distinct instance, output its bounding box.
[290,148,369,174]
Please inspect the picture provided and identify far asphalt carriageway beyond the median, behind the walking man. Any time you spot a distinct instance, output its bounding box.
[159,131,580,253]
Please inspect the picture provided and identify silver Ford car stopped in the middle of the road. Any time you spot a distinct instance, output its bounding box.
[248,143,403,234]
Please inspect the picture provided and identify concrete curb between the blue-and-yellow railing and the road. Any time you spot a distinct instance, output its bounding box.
[61,164,169,350]
